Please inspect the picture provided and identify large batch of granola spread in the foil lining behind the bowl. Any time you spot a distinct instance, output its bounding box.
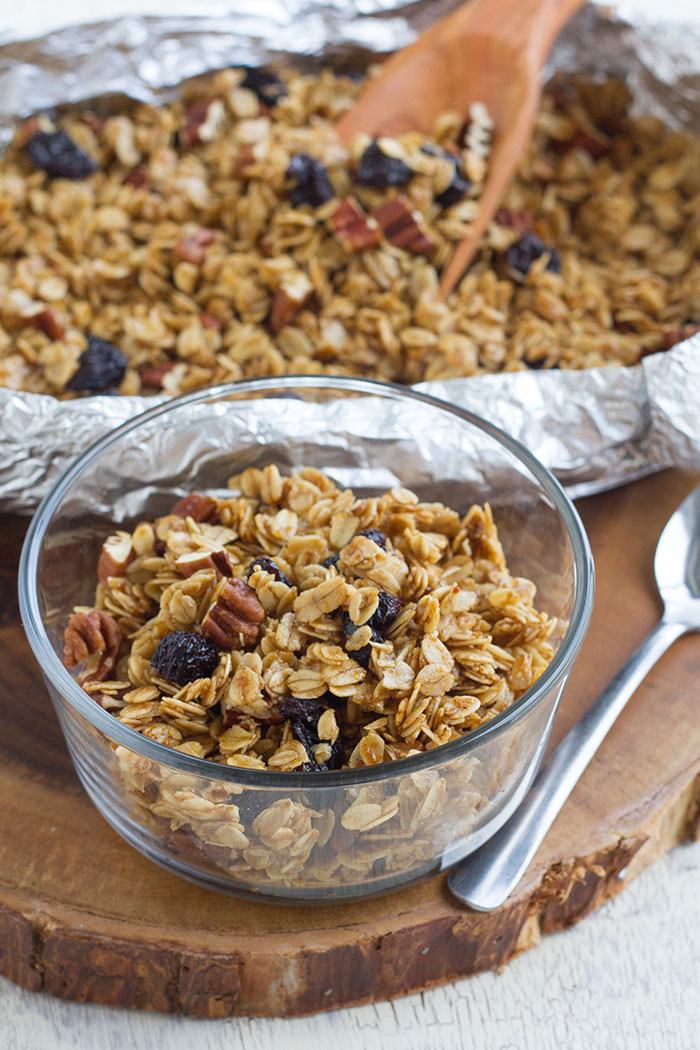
[0,69,700,398]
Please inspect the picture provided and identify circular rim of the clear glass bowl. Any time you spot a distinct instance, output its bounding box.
[18,375,595,789]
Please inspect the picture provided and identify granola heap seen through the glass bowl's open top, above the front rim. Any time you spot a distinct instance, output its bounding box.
[64,465,557,772]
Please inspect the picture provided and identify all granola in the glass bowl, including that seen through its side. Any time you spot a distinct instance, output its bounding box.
[64,465,560,885]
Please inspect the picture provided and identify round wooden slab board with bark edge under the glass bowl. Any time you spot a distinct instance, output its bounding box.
[0,473,700,1017]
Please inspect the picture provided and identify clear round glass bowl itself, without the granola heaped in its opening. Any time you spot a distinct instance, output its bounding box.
[19,376,593,902]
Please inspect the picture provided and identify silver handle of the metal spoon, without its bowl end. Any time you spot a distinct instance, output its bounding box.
[447,620,687,911]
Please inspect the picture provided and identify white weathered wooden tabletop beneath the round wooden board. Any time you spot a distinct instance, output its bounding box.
[5,0,700,1050]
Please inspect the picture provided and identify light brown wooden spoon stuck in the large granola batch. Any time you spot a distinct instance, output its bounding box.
[338,0,584,296]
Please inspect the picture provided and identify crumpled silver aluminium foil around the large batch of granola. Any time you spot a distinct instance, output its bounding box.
[0,0,700,512]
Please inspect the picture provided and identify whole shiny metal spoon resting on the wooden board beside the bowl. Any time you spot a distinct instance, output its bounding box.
[447,485,700,911]
